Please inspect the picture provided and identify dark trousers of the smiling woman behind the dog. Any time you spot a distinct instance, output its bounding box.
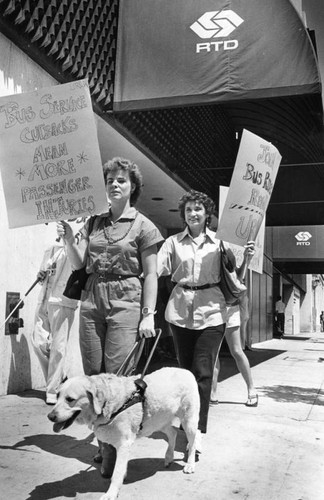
[170,323,225,433]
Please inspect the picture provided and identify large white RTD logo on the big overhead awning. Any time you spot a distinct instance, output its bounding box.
[190,10,243,53]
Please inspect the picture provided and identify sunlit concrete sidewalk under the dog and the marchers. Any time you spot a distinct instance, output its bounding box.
[0,333,324,500]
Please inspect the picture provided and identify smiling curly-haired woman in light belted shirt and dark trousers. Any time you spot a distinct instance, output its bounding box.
[158,191,226,452]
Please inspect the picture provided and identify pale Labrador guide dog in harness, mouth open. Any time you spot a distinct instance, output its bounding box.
[48,368,200,500]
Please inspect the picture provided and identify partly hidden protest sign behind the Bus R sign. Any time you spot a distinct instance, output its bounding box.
[219,186,265,274]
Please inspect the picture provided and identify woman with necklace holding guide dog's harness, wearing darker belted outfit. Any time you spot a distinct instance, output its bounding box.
[58,157,163,375]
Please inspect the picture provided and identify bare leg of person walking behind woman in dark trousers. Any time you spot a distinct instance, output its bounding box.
[225,326,255,398]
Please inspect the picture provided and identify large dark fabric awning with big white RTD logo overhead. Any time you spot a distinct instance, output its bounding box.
[114,0,321,111]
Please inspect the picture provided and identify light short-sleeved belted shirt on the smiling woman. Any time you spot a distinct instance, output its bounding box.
[158,228,226,330]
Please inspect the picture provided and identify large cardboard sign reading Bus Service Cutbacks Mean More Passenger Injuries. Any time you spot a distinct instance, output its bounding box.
[0,80,107,228]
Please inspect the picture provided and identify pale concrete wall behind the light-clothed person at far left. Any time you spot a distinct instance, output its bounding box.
[0,34,82,395]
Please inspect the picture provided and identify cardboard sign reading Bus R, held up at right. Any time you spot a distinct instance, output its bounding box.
[216,130,281,246]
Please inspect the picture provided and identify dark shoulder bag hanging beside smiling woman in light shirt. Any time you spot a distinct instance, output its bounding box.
[219,241,246,306]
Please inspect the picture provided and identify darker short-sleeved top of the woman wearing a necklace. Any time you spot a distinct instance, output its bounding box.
[81,207,163,276]
